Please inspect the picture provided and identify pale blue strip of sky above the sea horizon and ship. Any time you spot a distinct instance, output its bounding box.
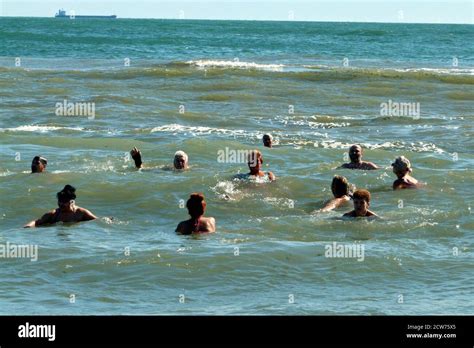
[0,0,474,24]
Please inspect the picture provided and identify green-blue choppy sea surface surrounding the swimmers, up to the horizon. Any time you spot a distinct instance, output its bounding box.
[0,18,474,315]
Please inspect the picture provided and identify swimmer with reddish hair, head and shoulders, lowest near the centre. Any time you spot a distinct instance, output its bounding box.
[176,193,216,234]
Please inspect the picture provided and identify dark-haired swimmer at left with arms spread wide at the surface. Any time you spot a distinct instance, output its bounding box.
[24,185,97,227]
